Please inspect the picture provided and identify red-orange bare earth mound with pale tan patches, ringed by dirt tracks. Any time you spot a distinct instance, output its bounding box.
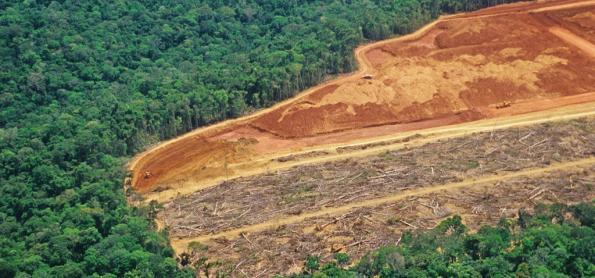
[252,8,595,138]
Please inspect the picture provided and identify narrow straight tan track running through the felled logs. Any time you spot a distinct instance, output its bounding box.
[171,157,595,253]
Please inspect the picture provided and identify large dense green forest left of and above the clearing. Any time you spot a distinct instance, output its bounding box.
[0,0,528,277]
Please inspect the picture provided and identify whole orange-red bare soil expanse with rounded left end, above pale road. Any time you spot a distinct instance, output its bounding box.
[130,1,595,196]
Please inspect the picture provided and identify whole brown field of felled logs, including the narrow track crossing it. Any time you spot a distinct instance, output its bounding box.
[165,117,595,277]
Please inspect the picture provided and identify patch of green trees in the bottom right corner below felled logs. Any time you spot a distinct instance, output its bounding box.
[294,203,595,278]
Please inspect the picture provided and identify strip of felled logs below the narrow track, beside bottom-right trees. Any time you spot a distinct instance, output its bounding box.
[183,166,595,277]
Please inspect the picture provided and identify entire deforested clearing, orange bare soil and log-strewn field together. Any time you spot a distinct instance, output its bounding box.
[128,1,595,277]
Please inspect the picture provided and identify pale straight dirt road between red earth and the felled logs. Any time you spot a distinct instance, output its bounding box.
[143,103,595,203]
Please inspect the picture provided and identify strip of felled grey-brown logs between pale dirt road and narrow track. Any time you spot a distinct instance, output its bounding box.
[160,118,595,238]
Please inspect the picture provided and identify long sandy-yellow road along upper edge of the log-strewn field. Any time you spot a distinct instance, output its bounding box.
[142,102,595,203]
